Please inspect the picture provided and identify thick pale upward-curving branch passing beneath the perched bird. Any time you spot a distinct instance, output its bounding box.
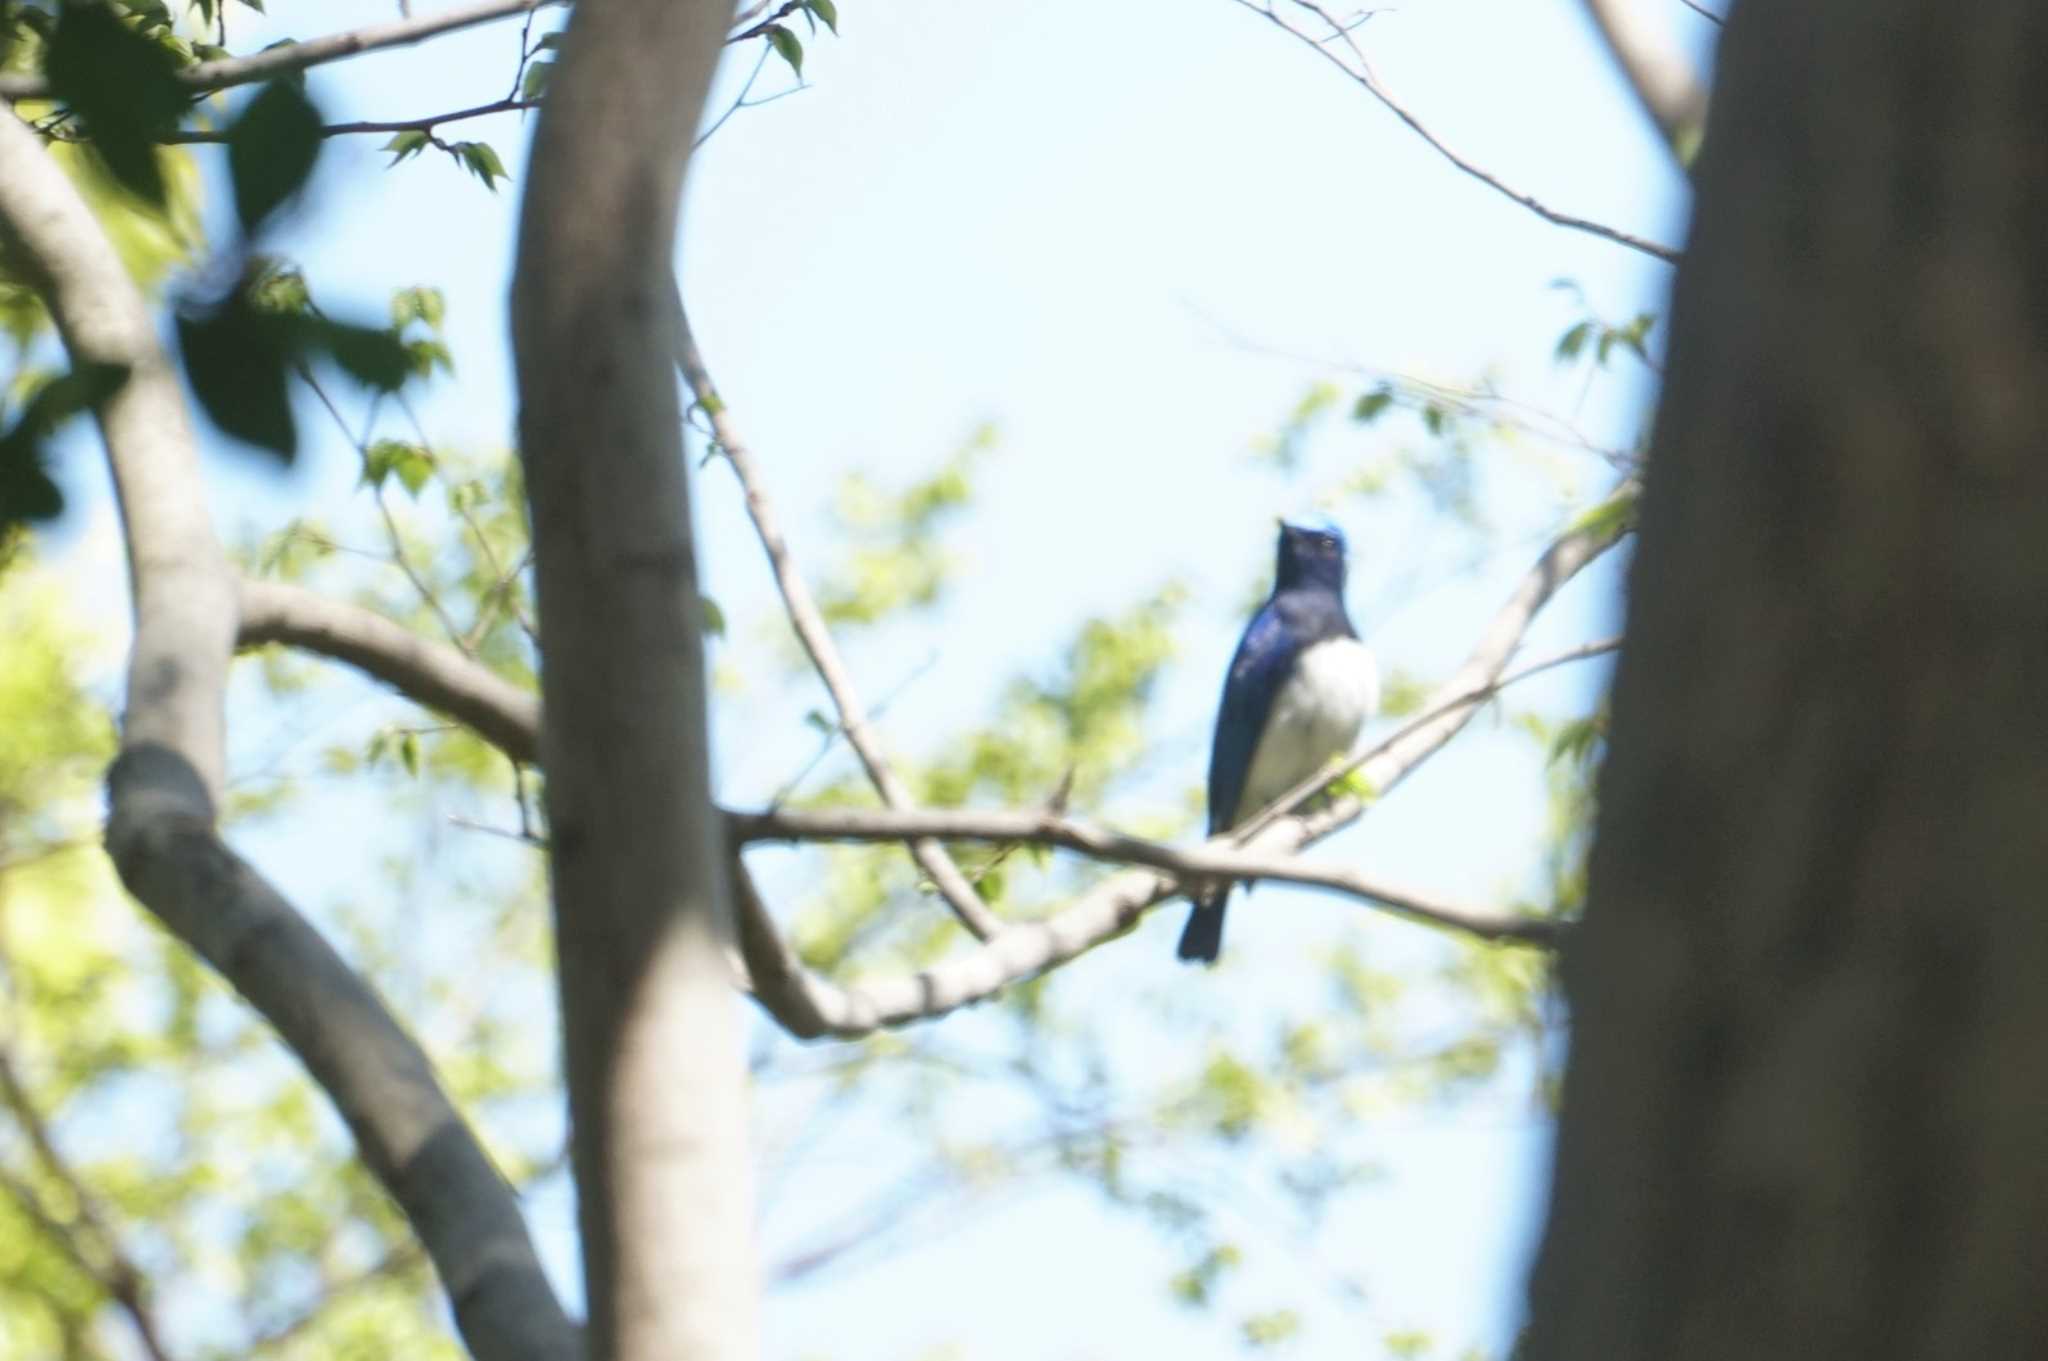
[733,518,1622,1040]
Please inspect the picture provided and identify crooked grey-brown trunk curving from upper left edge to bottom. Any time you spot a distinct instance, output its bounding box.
[0,108,580,1361]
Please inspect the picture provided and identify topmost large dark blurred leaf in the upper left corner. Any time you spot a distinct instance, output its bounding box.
[43,4,186,207]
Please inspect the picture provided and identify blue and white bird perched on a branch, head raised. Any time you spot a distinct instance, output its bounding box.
[1180,524,1380,964]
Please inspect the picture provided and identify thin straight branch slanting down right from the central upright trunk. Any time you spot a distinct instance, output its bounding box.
[674,293,1004,941]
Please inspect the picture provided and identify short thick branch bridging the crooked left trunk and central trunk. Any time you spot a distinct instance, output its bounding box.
[238,579,541,763]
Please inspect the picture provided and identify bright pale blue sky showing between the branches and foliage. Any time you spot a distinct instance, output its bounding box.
[36,0,1712,1361]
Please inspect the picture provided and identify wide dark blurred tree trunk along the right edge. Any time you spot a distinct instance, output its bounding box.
[1528,0,2048,1361]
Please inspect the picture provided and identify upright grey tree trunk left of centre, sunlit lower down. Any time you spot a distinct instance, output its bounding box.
[512,0,760,1361]
